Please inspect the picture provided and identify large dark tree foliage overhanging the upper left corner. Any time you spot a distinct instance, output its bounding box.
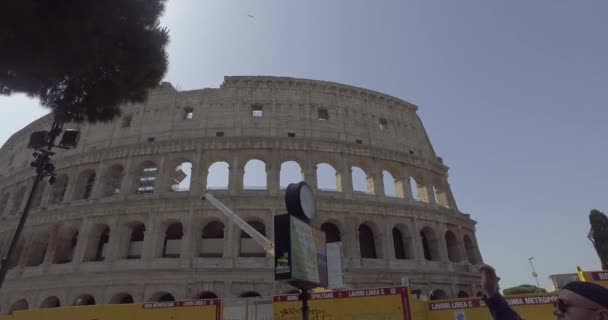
[0,0,169,122]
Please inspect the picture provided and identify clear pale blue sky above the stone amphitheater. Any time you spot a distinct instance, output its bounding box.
[0,0,608,287]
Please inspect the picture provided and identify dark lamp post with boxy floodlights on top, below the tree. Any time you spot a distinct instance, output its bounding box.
[0,119,80,288]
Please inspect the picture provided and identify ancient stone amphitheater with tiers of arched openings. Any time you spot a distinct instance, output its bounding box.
[0,76,481,313]
